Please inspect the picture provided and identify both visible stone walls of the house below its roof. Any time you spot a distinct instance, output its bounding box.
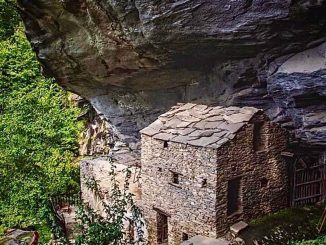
[142,114,288,245]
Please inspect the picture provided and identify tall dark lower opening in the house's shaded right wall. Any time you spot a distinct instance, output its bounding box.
[227,177,242,215]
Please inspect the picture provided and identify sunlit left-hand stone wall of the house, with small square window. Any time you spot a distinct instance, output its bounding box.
[142,135,217,245]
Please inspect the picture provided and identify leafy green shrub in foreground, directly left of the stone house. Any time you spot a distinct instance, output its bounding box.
[46,163,144,245]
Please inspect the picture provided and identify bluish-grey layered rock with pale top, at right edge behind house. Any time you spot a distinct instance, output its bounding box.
[267,43,326,144]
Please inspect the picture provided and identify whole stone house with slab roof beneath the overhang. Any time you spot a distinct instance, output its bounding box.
[141,103,288,245]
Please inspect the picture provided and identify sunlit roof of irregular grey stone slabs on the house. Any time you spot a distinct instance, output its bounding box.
[140,103,260,148]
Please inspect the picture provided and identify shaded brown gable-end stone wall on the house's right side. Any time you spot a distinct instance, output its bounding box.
[216,115,289,235]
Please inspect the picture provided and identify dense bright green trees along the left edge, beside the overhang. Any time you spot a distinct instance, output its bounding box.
[0,0,82,238]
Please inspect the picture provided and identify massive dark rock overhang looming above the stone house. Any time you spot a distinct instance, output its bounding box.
[18,0,326,147]
